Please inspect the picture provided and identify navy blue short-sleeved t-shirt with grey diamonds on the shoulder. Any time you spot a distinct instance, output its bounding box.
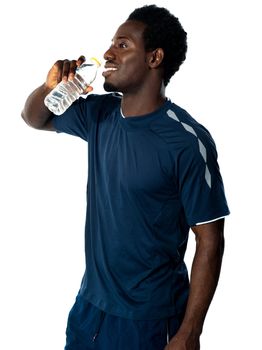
[53,94,229,319]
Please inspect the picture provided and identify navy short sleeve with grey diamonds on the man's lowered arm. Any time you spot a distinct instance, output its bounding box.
[177,136,229,226]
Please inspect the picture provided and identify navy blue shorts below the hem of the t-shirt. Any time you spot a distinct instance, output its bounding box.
[65,296,181,350]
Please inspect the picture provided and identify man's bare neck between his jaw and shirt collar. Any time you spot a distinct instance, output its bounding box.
[121,82,165,117]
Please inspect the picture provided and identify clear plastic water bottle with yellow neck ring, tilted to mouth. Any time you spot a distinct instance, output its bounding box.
[44,57,100,115]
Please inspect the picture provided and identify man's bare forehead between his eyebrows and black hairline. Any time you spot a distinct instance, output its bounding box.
[113,21,145,43]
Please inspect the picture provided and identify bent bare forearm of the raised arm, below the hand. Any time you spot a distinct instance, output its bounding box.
[22,84,52,130]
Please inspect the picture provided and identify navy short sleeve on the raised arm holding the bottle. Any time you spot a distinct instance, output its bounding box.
[52,94,102,141]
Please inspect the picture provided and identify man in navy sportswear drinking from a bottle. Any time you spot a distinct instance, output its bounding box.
[22,5,229,350]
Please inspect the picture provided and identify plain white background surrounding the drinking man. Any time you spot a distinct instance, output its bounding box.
[0,0,262,350]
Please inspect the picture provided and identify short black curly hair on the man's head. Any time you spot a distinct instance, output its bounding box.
[127,5,187,86]
